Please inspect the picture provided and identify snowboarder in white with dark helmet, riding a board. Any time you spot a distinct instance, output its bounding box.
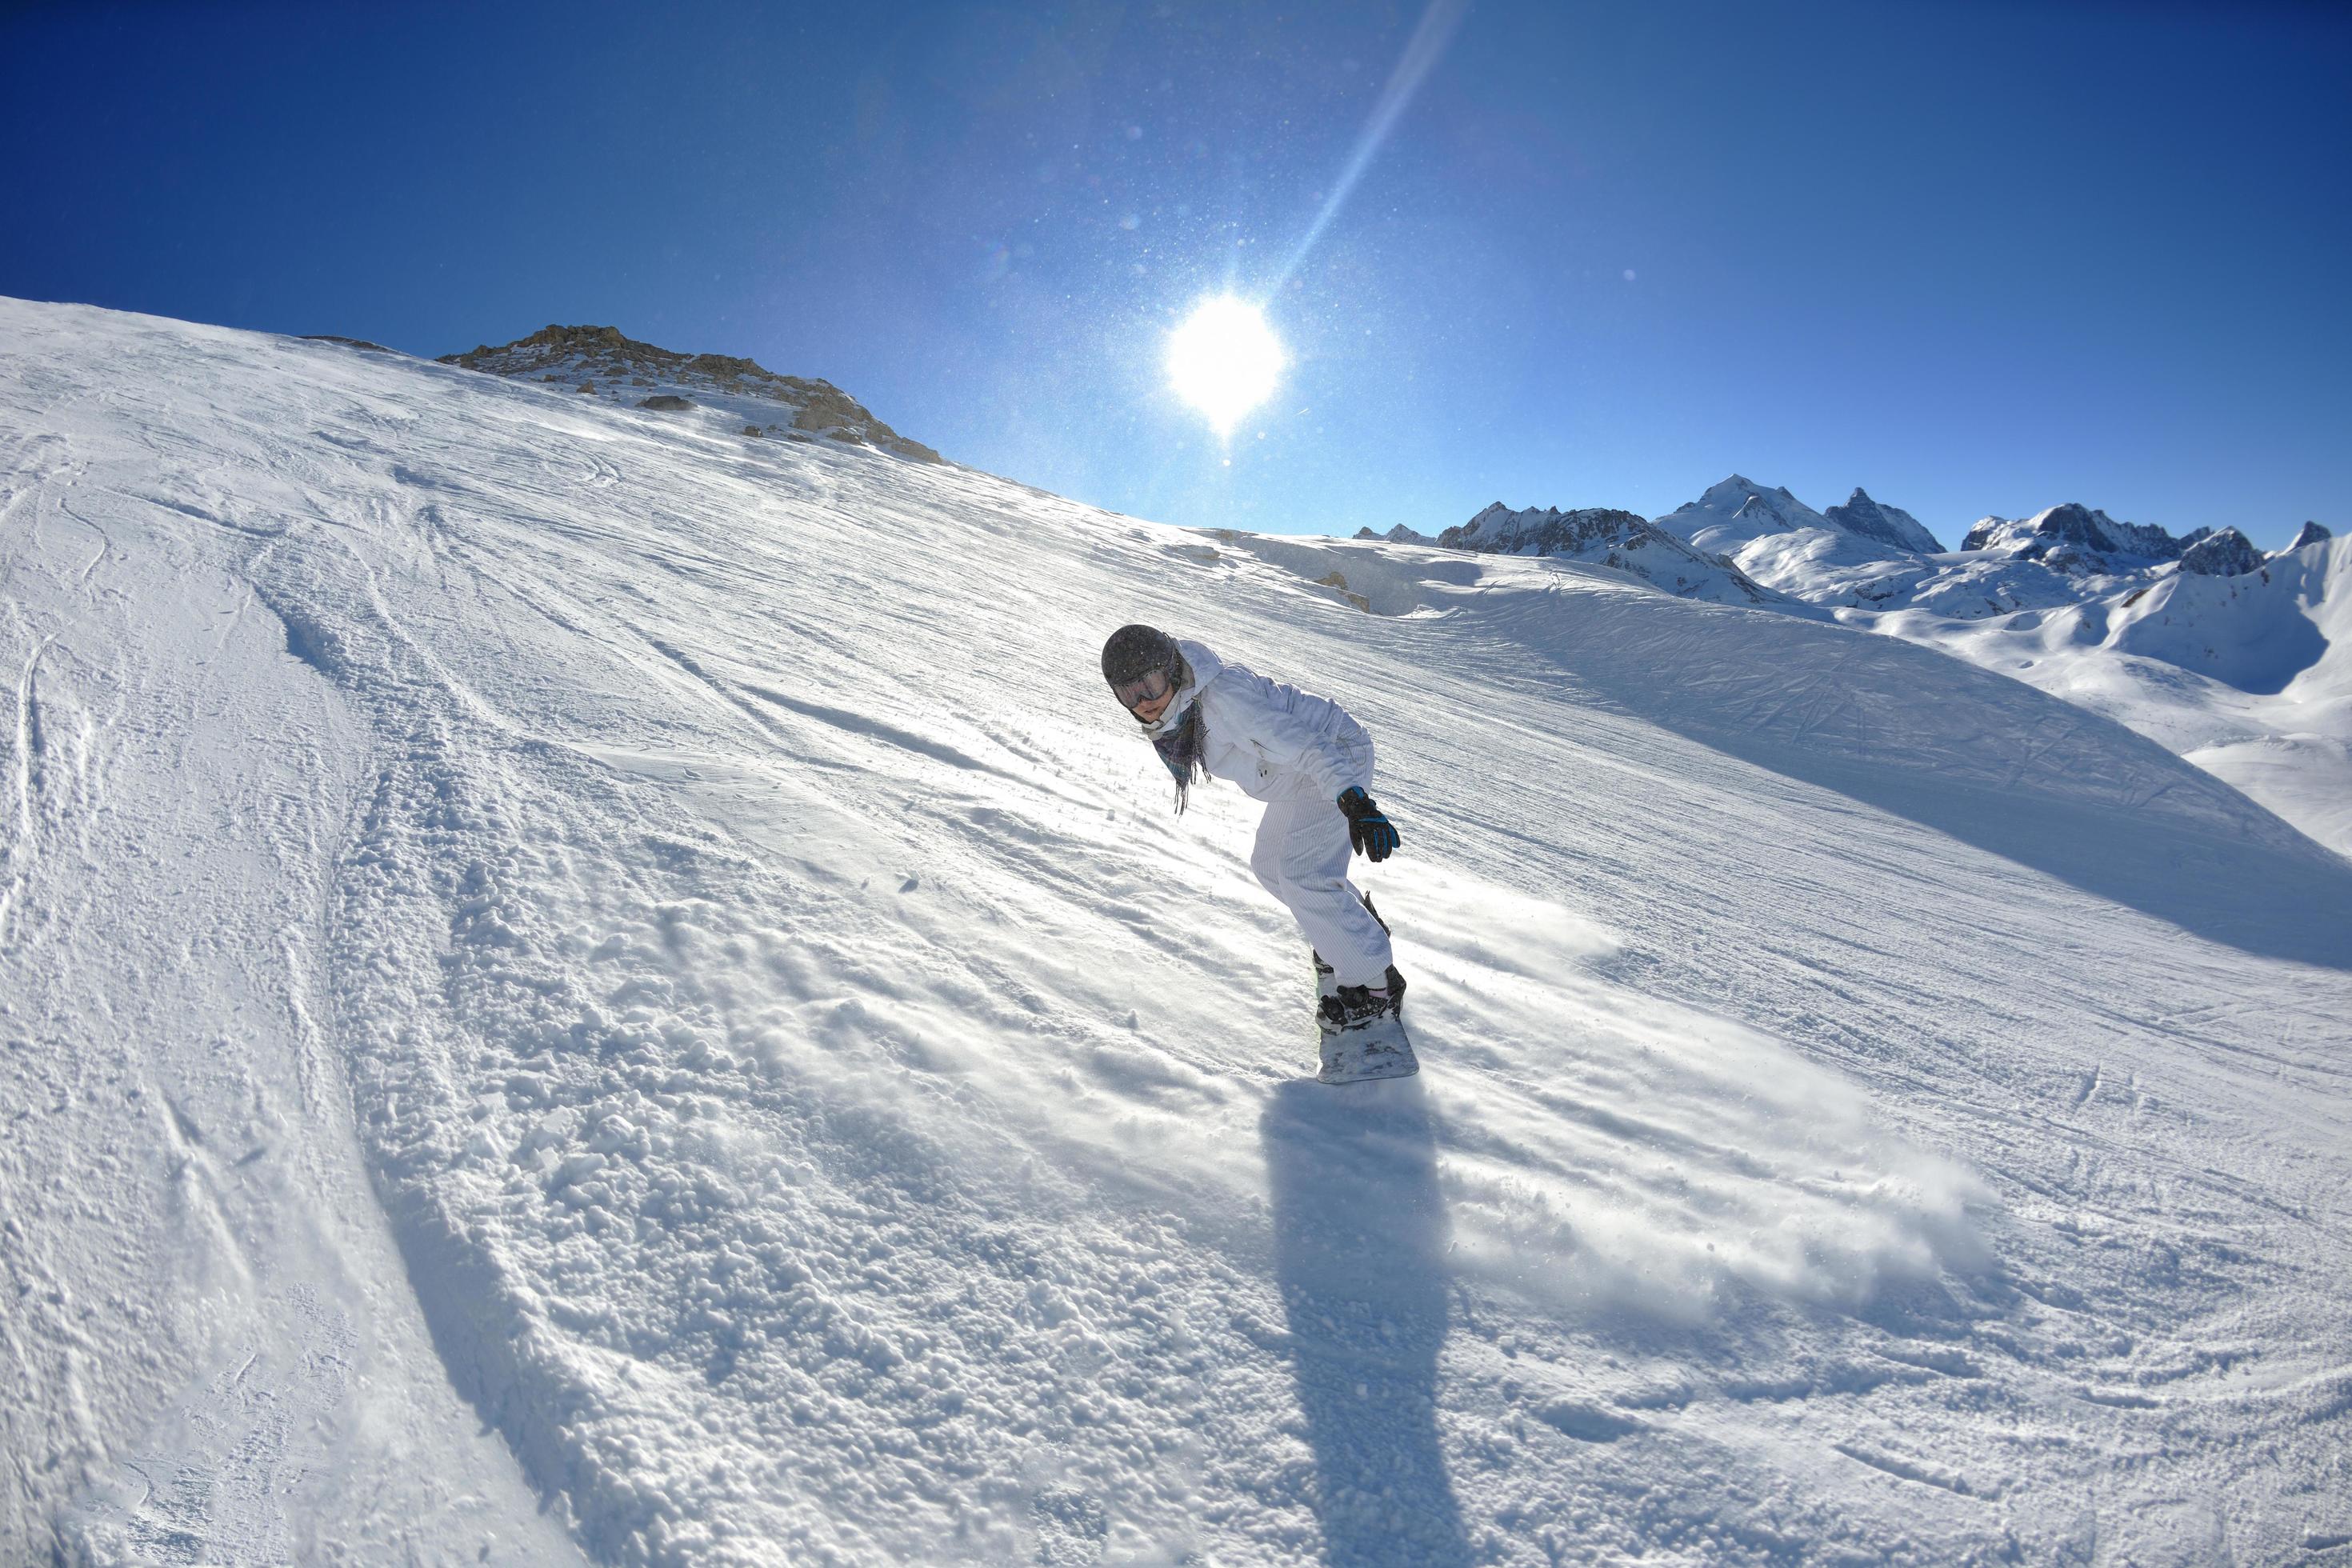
[1103,626,1418,1084]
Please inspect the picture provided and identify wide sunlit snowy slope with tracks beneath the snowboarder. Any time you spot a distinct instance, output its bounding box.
[0,303,2352,1563]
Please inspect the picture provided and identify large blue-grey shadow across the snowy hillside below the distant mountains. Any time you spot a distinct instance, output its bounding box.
[1529,599,2352,969]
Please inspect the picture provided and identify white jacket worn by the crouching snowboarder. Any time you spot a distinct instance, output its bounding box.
[1146,642,1371,799]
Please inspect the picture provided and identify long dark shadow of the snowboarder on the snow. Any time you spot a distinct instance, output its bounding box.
[1258,1079,1470,1568]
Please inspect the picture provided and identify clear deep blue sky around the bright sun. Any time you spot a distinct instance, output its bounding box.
[0,0,2352,546]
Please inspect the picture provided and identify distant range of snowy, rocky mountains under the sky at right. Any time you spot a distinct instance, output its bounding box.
[1357,475,2352,854]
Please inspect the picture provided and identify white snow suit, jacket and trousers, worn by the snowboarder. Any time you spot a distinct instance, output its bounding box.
[1146,642,1390,985]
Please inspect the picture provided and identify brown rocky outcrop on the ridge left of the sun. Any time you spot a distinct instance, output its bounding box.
[440,325,941,463]
